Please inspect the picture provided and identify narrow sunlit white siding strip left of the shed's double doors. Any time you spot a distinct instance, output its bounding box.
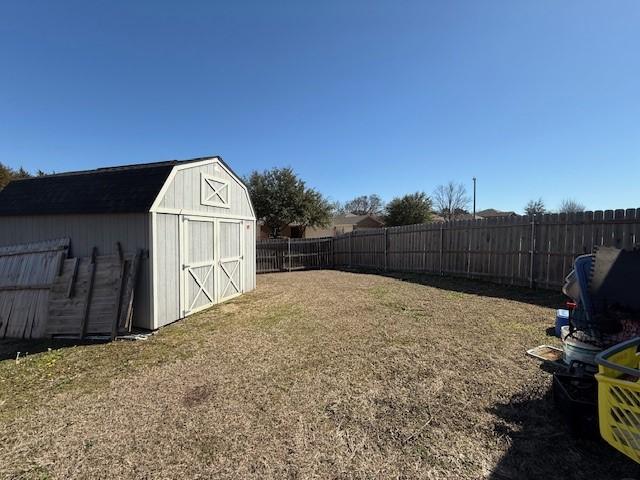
[155,213,182,327]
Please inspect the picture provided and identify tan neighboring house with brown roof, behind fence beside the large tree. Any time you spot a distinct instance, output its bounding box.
[257,213,384,240]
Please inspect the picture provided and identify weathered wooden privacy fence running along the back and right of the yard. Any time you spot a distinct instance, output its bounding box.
[257,209,640,289]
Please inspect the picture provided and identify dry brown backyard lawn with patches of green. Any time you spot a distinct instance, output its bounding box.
[0,271,640,480]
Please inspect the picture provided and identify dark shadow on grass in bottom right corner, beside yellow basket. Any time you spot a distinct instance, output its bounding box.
[488,390,640,480]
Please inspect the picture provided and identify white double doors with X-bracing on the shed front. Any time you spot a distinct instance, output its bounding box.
[180,215,244,316]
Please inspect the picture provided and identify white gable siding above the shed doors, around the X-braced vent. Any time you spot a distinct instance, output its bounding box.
[159,163,253,217]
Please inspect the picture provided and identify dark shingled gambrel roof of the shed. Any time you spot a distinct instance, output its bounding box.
[0,157,245,215]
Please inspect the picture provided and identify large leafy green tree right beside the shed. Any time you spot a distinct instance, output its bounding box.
[245,168,331,237]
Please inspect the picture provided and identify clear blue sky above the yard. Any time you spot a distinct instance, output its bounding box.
[0,0,640,210]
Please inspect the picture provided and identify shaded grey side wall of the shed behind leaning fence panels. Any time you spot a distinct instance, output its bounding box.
[0,213,153,328]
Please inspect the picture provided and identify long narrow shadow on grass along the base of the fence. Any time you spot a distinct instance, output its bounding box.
[341,269,567,308]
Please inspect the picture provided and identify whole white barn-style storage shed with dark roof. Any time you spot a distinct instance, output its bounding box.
[0,157,256,329]
